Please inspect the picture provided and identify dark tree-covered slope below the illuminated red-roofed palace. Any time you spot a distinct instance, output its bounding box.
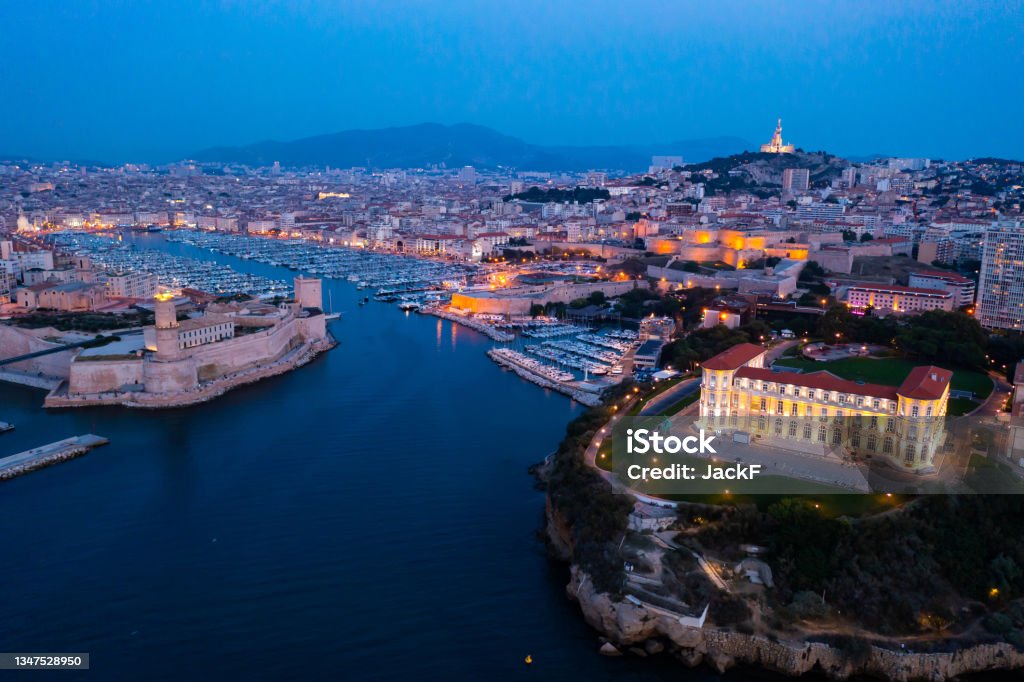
[696,496,1024,646]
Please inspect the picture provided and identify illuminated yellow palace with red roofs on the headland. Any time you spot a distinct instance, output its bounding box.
[700,343,952,473]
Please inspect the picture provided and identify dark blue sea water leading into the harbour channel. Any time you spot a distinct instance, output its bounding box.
[0,236,744,682]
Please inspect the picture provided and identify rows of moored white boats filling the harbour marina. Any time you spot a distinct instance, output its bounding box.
[34,229,639,403]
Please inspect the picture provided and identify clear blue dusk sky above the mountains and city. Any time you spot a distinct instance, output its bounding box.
[0,0,1024,162]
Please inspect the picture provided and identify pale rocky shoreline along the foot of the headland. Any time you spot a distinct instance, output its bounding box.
[545,497,1024,682]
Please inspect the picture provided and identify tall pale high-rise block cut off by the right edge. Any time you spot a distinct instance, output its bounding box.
[978,221,1024,331]
